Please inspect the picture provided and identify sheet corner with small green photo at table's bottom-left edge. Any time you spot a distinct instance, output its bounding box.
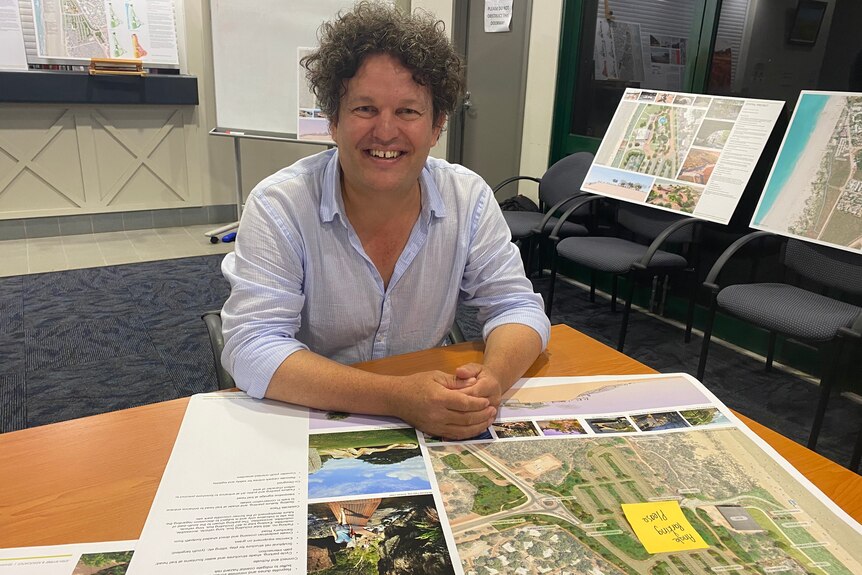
[0,541,137,575]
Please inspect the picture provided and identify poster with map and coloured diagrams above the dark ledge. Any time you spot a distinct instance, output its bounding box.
[32,0,179,66]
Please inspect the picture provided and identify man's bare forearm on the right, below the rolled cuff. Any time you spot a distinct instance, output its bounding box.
[482,323,542,392]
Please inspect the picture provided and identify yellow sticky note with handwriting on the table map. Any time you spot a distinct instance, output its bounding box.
[622,501,709,553]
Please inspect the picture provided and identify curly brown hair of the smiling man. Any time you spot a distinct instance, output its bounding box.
[300,2,464,125]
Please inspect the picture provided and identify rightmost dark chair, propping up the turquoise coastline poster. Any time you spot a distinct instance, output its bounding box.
[697,232,862,454]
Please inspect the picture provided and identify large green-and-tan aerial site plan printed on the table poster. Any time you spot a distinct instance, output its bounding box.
[427,432,862,575]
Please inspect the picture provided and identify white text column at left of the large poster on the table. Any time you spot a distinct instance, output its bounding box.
[128,393,308,575]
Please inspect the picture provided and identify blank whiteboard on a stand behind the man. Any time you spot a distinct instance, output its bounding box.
[210,0,353,137]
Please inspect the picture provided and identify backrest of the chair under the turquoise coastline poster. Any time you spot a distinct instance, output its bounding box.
[784,238,862,295]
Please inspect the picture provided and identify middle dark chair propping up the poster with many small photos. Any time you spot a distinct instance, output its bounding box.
[545,200,701,351]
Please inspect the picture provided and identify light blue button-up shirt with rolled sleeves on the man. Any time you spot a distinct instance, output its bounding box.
[222,150,550,397]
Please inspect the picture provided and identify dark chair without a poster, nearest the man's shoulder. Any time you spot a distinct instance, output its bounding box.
[494,152,593,276]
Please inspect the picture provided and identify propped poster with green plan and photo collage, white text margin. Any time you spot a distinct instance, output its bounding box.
[592,88,784,224]
